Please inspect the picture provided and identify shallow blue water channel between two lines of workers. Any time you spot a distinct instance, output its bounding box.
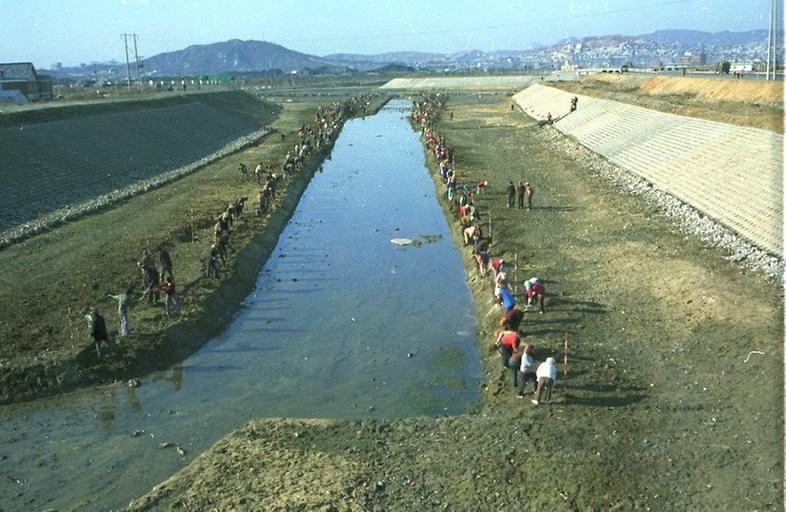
[0,100,481,511]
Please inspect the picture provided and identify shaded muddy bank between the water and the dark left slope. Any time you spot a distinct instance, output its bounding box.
[0,96,386,403]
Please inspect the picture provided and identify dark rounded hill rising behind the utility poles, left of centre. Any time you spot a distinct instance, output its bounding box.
[144,39,337,76]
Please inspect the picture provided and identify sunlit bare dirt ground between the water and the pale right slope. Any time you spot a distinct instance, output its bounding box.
[129,95,783,511]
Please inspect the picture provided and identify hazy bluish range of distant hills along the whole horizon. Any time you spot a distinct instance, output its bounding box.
[55,30,767,78]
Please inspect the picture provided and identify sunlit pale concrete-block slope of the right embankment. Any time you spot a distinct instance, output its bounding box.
[513,85,783,257]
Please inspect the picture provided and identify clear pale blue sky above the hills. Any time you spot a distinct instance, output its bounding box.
[0,0,782,68]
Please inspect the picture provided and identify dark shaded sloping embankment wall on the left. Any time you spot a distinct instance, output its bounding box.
[0,92,270,229]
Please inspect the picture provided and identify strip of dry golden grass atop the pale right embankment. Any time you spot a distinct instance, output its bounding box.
[548,74,783,133]
